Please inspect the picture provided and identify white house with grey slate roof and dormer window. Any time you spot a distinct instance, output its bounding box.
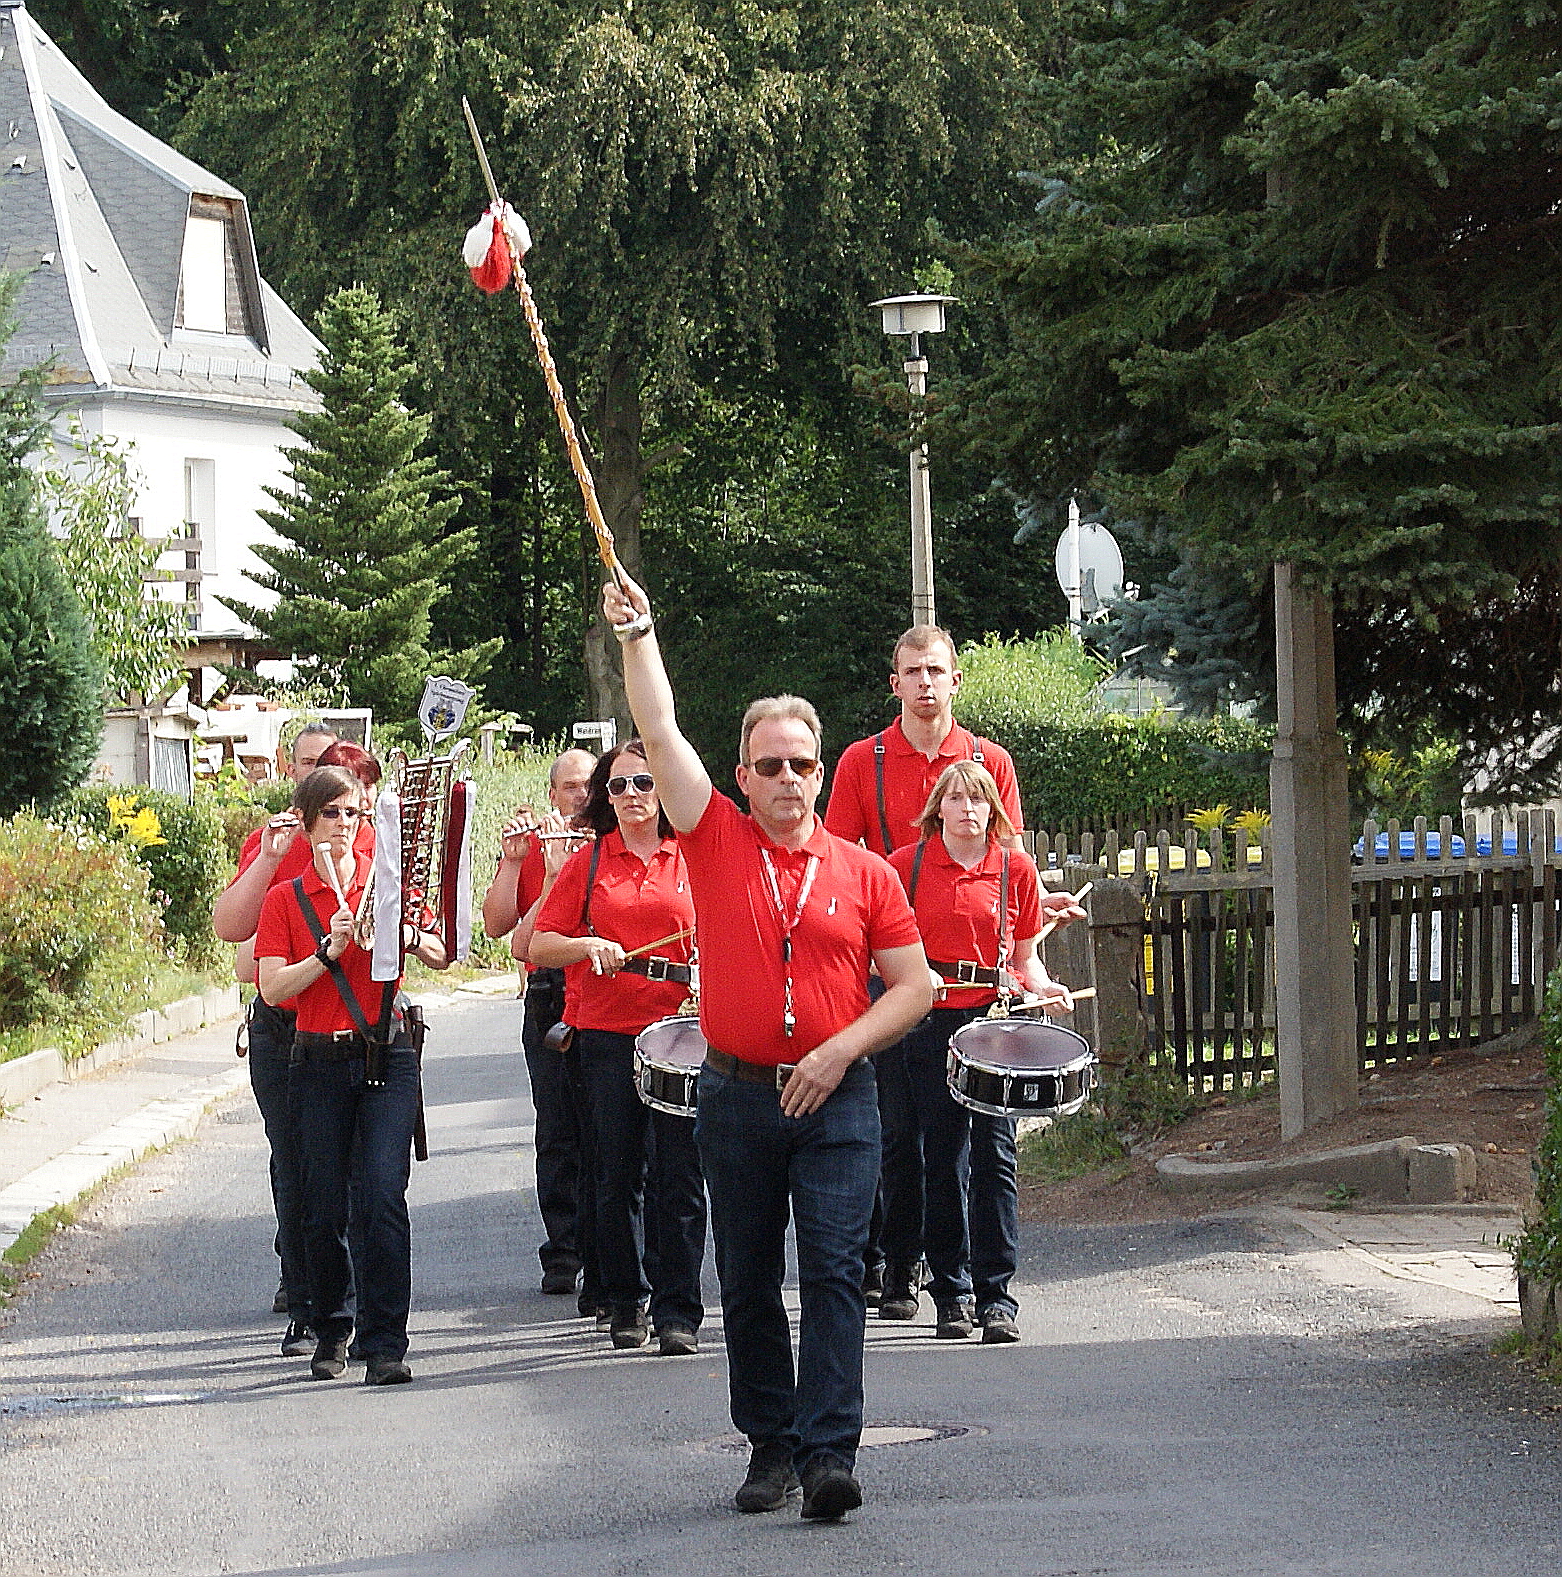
[0,0,319,781]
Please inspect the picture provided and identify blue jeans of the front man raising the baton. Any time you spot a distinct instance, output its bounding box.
[694,1061,879,1468]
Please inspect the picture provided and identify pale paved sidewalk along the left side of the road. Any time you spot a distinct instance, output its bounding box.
[0,975,516,1254]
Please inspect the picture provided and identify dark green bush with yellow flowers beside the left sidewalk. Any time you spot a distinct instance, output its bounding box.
[62,785,232,964]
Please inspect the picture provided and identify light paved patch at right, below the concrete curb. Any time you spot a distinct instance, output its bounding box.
[1264,1205,1523,1315]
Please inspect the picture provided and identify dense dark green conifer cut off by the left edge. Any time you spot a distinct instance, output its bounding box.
[0,278,103,815]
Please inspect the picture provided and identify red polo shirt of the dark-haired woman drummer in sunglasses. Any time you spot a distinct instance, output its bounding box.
[535,831,694,1035]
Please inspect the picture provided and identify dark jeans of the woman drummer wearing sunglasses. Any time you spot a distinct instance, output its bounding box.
[574,1030,705,1331]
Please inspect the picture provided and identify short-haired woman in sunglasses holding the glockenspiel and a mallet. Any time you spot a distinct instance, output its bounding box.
[256,766,445,1385]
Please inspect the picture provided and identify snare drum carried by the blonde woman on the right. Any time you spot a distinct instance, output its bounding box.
[950,1019,1095,1117]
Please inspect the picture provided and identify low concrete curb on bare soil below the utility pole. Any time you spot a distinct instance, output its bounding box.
[1155,1135,1475,1205]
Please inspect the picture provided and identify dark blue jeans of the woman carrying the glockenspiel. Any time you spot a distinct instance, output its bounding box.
[292,1042,418,1359]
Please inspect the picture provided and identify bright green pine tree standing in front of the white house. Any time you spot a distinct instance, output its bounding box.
[230,287,497,724]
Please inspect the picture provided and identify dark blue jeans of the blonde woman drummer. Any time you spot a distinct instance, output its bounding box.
[893,1008,1019,1314]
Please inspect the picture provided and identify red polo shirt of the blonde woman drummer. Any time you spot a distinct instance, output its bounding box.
[890,837,1041,1008]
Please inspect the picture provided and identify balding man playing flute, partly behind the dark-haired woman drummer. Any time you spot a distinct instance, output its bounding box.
[483,751,600,1314]
